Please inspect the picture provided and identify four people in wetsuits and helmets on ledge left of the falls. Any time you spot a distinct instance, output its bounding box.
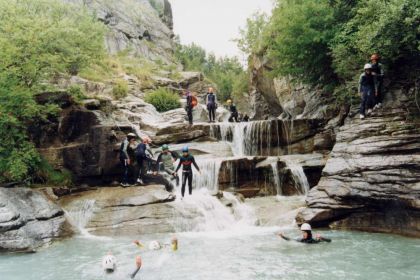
[120,133,200,197]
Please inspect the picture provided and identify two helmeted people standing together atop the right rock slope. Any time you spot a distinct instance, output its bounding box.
[359,53,384,120]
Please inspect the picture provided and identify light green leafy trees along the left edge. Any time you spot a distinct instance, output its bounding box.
[0,0,104,182]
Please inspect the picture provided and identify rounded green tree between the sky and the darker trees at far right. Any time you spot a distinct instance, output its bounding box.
[266,0,337,83]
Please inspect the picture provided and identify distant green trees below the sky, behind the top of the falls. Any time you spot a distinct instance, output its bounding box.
[175,44,248,101]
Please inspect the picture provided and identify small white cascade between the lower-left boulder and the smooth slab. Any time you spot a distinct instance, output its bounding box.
[65,199,95,236]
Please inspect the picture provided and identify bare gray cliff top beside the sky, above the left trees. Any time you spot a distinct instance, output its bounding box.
[62,0,174,62]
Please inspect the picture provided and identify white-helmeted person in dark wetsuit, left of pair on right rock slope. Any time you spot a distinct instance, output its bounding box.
[359,63,375,120]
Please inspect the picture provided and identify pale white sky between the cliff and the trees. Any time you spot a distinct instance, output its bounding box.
[170,0,273,59]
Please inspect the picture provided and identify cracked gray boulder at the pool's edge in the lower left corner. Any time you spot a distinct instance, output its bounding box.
[0,188,72,252]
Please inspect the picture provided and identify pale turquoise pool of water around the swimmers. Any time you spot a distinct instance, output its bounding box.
[0,227,420,280]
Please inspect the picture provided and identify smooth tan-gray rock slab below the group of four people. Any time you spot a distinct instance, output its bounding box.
[60,186,203,236]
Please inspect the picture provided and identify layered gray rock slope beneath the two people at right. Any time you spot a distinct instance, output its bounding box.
[297,87,420,236]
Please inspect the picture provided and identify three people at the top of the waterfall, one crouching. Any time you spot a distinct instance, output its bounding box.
[185,87,249,125]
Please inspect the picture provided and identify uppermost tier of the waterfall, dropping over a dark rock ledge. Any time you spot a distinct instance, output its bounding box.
[210,120,280,156]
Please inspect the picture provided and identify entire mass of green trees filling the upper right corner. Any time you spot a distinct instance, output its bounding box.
[236,0,420,103]
